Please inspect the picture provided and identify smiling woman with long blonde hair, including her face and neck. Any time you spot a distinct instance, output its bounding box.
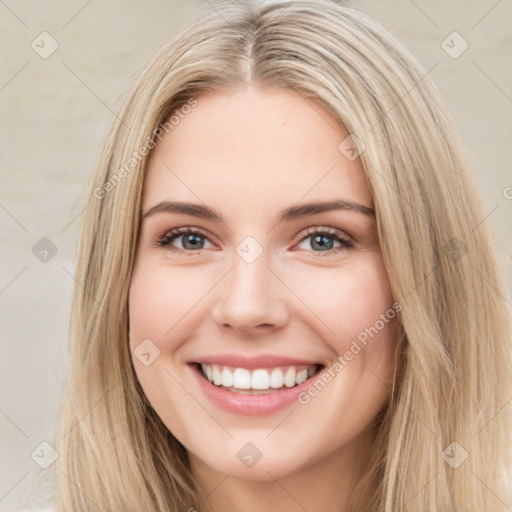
[22,0,511,512]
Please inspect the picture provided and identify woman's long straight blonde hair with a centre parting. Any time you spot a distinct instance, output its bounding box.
[23,0,512,512]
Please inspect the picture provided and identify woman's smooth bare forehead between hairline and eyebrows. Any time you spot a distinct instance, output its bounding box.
[143,88,372,210]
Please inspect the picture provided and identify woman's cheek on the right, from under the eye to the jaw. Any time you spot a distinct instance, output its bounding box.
[286,253,399,434]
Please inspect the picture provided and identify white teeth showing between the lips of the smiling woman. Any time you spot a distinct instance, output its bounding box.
[194,363,324,395]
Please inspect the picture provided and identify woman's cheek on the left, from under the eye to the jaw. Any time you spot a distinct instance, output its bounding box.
[129,259,204,439]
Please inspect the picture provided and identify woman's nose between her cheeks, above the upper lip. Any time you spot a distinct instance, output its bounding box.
[208,254,288,337]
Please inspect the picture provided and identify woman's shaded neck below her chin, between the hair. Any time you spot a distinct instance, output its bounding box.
[189,424,375,512]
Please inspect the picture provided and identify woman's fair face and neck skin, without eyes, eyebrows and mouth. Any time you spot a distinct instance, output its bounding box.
[129,86,398,512]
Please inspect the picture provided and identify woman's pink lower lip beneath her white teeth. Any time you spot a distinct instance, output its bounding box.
[189,364,318,416]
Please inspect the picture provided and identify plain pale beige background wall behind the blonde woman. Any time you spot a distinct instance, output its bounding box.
[0,0,512,511]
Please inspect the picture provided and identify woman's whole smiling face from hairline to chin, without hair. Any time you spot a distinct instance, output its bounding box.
[129,88,397,480]
